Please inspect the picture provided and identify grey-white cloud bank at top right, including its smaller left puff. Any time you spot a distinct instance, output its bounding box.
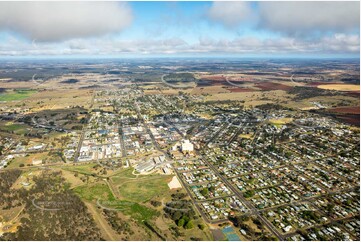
[207,1,360,35]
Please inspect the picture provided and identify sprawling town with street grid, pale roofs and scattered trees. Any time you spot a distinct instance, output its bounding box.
[0,60,360,240]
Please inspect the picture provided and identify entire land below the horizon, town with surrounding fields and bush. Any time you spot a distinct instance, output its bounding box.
[0,57,360,240]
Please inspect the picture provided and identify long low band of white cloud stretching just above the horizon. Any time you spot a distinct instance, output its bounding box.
[0,34,360,56]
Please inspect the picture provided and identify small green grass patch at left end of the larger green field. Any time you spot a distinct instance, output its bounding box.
[73,183,116,201]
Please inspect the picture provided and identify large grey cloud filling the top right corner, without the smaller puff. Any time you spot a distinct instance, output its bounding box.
[259,1,360,35]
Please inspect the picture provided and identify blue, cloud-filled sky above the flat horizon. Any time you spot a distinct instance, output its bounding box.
[0,1,360,58]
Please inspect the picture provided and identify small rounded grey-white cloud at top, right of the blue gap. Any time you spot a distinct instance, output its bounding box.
[207,2,254,28]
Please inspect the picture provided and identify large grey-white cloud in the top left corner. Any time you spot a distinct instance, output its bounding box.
[0,2,132,41]
